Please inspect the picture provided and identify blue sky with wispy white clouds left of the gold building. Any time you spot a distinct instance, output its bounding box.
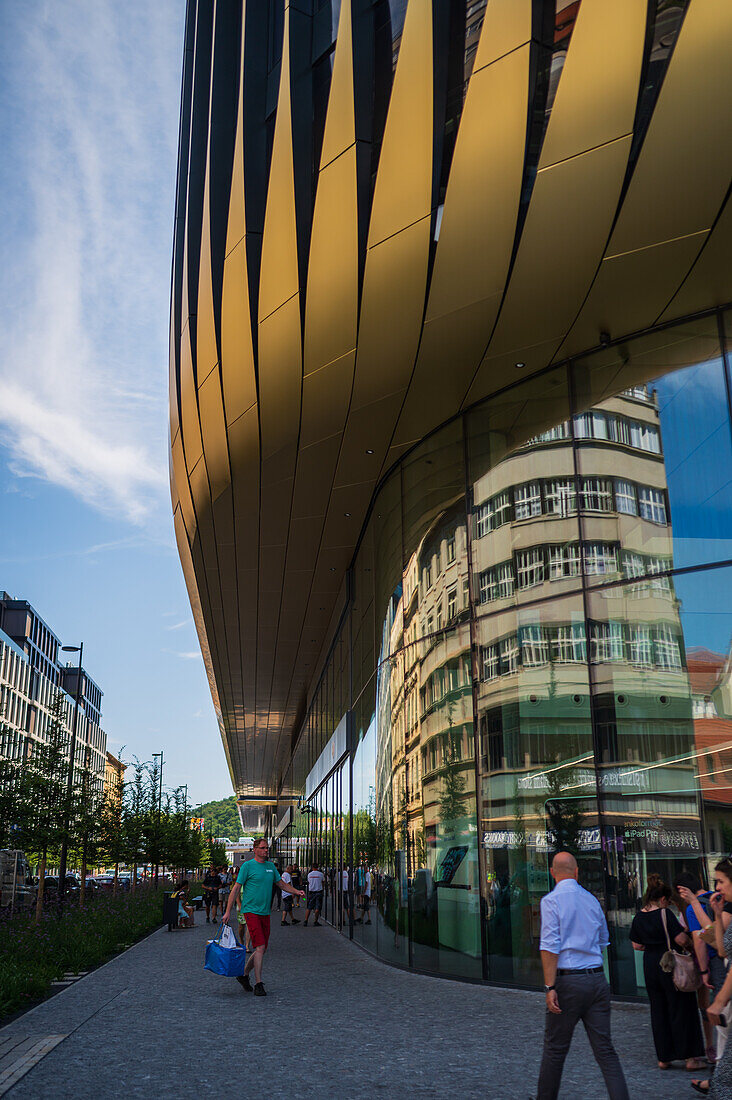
[0,0,231,800]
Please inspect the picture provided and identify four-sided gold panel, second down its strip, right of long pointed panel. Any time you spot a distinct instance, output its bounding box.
[304,145,359,375]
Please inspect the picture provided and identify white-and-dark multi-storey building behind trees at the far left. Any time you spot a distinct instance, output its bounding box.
[0,591,107,792]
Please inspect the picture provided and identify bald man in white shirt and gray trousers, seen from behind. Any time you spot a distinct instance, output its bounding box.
[530,851,630,1100]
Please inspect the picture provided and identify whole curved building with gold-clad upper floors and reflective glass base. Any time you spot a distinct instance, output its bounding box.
[171,0,732,997]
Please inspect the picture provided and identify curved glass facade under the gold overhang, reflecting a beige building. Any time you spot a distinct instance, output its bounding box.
[278,314,732,997]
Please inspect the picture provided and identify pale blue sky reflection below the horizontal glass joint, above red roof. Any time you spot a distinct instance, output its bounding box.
[674,569,732,655]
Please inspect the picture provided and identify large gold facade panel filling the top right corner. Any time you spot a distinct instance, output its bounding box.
[608,0,732,255]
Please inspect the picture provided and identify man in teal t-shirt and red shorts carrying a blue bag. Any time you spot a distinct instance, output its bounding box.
[221,839,304,997]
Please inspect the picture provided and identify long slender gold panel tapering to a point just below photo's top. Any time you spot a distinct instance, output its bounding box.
[259,8,298,321]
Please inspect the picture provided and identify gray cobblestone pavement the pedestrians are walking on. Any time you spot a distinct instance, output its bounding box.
[0,914,708,1100]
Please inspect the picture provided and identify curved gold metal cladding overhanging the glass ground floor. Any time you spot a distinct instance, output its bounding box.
[171,0,732,795]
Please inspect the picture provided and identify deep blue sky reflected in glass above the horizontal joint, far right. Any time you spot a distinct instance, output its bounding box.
[652,360,732,568]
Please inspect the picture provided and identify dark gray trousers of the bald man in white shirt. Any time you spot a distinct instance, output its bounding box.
[536,974,630,1100]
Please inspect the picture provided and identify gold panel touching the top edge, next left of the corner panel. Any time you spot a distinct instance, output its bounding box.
[539,0,646,171]
